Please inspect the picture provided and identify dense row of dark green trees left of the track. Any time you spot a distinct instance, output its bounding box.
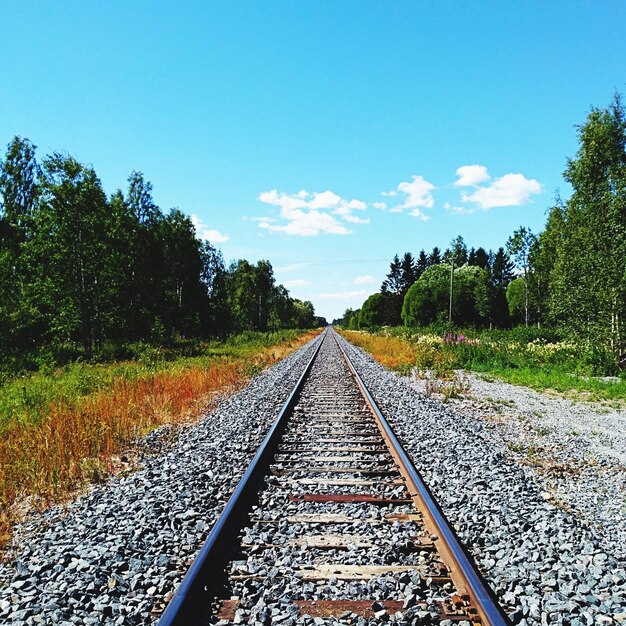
[0,136,324,374]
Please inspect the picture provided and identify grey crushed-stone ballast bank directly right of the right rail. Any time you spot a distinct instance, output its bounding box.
[340,339,626,626]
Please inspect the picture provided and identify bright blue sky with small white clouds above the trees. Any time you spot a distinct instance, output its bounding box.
[0,0,626,319]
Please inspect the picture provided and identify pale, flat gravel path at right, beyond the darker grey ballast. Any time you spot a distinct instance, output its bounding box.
[420,373,626,561]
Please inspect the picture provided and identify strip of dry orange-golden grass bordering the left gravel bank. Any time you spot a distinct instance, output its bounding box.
[0,331,319,546]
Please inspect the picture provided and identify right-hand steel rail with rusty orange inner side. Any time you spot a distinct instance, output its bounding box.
[332,330,511,626]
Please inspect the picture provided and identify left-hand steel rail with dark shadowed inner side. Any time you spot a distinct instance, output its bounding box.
[159,331,328,626]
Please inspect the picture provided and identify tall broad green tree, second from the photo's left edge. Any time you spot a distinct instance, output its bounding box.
[28,153,112,352]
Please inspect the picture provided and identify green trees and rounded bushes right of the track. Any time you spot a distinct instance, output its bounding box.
[335,94,626,370]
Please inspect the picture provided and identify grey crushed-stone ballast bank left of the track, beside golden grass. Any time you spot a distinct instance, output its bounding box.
[0,338,320,625]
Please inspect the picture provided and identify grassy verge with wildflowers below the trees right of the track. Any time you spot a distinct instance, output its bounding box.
[342,327,626,404]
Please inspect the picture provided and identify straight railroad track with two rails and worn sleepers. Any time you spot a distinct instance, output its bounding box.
[159,329,509,626]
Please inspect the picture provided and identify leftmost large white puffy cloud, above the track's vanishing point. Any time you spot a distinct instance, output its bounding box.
[258,189,369,237]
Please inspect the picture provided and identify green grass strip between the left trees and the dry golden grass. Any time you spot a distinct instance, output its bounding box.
[0,330,303,428]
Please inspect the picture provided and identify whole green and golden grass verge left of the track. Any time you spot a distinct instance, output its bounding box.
[0,331,317,545]
